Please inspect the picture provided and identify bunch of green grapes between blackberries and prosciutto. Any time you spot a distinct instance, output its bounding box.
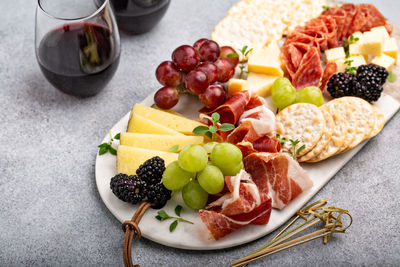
[162,142,243,209]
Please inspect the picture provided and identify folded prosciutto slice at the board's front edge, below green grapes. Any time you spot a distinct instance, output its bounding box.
[199,170,271,240]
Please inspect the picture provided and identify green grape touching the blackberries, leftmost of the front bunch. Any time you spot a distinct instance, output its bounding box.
[162,161,195,191]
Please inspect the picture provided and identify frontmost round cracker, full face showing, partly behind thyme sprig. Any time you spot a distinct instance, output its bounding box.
[276,103,325,157]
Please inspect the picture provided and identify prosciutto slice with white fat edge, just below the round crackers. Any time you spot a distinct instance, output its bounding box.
[243,152,313,209]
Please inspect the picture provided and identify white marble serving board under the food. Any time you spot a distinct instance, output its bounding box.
[96,94,400,250]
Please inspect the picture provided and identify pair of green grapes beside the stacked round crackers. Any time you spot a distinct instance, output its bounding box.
[271,78,324,109]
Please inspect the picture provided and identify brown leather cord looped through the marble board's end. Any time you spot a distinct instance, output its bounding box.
[122,202,153,267]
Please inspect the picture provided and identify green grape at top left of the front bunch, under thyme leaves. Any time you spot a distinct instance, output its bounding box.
[178,145,208,172]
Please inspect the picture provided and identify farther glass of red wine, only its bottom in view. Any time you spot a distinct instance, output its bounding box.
[111,0,171,34]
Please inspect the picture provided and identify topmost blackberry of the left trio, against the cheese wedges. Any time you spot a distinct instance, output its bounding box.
[136,156,165,185]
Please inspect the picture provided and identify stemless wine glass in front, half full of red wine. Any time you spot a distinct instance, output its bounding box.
[35,0,121,97]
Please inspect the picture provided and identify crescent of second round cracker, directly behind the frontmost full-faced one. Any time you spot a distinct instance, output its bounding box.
[297,107,335,162]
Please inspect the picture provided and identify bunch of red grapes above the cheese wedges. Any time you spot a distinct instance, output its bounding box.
[154,38,239,109]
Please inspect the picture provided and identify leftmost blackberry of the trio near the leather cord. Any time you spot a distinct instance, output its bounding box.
[110,173,147,204]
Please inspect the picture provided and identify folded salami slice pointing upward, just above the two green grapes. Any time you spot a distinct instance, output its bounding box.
[292,47,322,90]
